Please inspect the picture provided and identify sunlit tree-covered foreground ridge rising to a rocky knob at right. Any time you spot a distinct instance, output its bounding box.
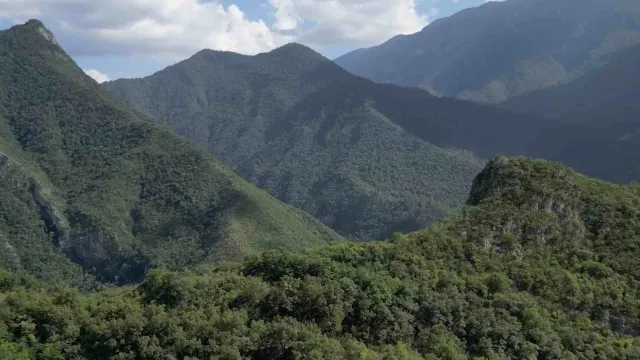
[0,157,640,360]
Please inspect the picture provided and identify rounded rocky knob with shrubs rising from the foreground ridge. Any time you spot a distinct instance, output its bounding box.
[463,157,586,253]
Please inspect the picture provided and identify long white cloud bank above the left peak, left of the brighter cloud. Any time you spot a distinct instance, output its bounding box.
[0,0,289,58]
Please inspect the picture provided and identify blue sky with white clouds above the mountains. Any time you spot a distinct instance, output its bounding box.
[0,0,486,82]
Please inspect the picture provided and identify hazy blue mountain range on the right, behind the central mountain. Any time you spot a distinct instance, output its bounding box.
[335,0,640,183]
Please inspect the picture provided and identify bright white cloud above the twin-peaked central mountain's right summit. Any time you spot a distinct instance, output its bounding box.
[269,0,428,46]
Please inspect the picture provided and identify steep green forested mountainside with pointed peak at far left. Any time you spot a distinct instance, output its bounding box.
[0,20,339,283]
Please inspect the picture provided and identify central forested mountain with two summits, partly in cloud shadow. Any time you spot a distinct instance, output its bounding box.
[103,44,537,240]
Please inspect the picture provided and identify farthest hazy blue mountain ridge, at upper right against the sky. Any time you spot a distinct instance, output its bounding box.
[335,0,640,103]
